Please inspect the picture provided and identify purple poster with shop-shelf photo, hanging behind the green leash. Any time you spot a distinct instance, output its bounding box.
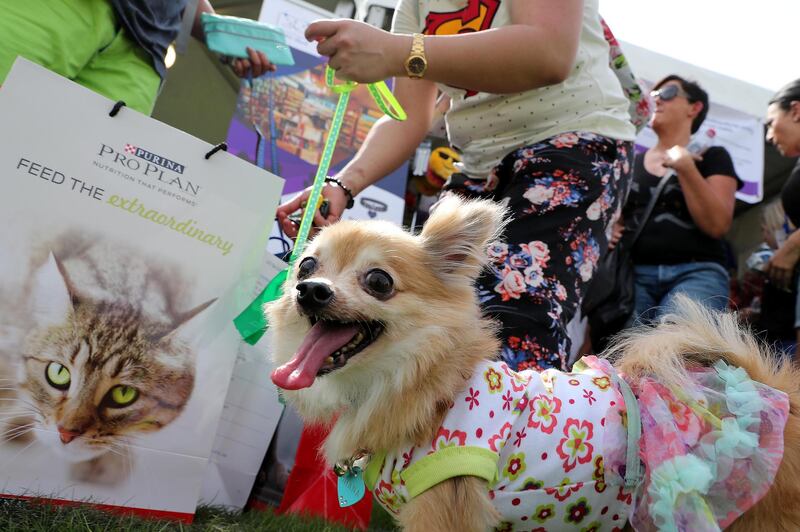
[227,0,408,253]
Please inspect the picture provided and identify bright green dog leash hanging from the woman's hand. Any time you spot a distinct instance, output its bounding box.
[233,67,407,345]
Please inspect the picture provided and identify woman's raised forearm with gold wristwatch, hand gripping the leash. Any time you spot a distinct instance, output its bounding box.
[306,0,583,94]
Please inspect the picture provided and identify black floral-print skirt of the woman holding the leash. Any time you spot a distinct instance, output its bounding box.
[445,132,633,370]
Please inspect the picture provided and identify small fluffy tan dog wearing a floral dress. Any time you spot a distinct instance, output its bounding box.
[267,197,800,532]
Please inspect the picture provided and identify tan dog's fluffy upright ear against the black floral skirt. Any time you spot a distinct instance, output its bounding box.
[420,195,505,279]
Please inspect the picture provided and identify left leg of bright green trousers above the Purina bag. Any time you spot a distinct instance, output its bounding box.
[0,0,116,84]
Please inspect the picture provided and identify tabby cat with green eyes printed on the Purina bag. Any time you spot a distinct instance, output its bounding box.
[0,235,214,484]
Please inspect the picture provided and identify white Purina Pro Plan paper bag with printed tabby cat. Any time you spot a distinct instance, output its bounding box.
[0,59,283,520]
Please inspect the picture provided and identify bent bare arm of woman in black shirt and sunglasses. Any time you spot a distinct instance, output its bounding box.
[663,146,737,238]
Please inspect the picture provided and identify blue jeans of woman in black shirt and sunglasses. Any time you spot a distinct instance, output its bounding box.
[633,262,729,323]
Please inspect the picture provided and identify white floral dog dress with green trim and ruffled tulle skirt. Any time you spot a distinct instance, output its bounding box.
[364,357,788,532]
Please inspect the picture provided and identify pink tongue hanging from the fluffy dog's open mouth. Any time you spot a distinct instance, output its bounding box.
[272,321,358,390]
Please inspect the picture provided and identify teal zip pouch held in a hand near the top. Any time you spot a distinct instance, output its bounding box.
[200,13,294,66]
